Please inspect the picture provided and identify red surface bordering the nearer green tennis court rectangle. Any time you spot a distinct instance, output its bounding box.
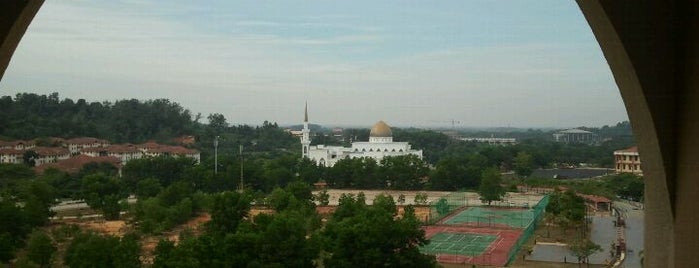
[423,225,522,266]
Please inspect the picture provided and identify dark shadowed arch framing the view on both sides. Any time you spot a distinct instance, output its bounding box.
[0,0,699,267]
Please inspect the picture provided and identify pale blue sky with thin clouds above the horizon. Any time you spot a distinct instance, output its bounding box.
[0,0,628,127]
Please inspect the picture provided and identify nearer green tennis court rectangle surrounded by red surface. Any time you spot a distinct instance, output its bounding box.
[420,233,497,256]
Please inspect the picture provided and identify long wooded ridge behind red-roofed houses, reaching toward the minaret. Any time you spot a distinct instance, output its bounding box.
[0,93,300,154]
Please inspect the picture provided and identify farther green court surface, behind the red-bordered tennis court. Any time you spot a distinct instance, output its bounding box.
[444,207,534,228]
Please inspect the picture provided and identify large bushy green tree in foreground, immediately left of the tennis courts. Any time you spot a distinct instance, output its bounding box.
[321,195,435,267]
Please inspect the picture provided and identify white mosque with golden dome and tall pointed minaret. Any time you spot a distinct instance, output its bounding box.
[301,105,422,167]
